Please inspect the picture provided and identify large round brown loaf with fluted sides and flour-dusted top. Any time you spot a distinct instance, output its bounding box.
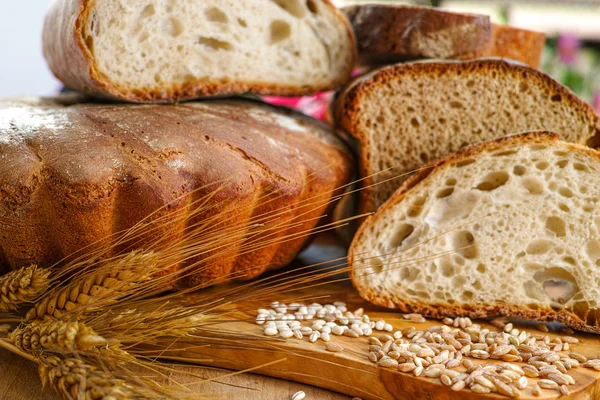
[0,97,352,285]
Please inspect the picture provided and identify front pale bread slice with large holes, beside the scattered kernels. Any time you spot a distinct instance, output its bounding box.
[349,133,600,333]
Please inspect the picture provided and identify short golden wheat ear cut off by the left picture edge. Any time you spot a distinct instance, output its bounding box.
[0,265,50,312]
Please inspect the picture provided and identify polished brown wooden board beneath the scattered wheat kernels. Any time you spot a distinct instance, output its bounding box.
[158,280,600,400]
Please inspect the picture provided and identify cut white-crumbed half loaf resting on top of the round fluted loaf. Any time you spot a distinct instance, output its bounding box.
[43,0,356,102]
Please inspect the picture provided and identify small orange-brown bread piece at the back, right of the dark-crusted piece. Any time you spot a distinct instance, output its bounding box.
[458,24,546,68]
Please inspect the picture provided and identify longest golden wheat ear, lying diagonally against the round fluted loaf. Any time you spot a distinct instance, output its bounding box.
[25,252,161,321]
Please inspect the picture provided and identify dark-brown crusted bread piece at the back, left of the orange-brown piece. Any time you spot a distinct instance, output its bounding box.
[342,4,491,63]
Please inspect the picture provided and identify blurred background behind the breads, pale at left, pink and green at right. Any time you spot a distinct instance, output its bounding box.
[0,0,600,112]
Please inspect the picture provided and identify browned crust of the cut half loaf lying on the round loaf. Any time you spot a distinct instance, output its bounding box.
[42,0,357,103]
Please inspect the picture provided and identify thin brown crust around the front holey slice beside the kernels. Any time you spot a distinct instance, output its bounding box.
[348,132,600,334]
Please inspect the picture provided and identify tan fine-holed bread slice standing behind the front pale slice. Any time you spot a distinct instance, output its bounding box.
[336,59,600,212]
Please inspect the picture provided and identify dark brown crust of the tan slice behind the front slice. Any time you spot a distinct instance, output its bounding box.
[334,58,600,217]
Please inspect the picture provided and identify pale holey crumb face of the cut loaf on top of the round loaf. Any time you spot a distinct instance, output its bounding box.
[84,0,353,90]
